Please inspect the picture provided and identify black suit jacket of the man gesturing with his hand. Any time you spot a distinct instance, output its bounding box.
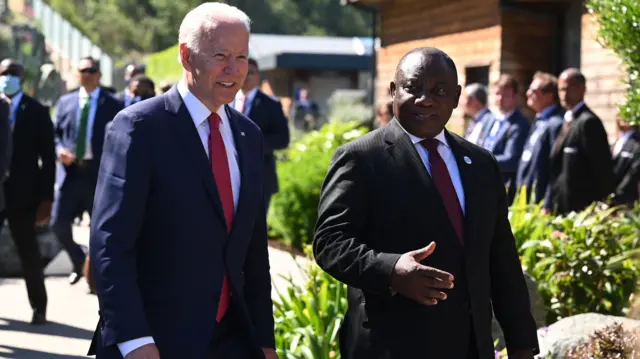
[313,120,538,359]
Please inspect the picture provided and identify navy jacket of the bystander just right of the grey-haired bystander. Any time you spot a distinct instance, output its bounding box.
[482,109,531,187]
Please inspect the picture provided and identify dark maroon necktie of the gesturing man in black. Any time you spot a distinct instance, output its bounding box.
[422,138,464,244]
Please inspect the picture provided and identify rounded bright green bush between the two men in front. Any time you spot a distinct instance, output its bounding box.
[268,121,368,248]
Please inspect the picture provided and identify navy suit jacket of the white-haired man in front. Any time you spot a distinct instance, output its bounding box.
[90,86,275,359]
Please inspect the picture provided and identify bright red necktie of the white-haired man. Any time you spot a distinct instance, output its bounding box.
[209,113,234,323]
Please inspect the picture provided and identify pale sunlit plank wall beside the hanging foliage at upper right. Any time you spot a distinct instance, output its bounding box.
[581,14,625,143]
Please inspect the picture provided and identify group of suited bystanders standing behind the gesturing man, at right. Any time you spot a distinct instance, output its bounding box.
[377,68,640,214]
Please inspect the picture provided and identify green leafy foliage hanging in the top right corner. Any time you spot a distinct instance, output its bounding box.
[588,0,640,124]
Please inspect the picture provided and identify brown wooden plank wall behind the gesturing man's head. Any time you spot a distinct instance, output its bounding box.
[376,0,501,132]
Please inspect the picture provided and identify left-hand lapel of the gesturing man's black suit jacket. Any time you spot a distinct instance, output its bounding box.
[384,119,462,247]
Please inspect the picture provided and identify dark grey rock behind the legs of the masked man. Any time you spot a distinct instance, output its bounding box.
[0,223,61,278]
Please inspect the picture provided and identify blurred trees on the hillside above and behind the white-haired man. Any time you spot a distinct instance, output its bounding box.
[45,0,371,57]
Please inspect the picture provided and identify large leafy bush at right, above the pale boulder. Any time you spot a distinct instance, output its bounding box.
[512,204,639,324]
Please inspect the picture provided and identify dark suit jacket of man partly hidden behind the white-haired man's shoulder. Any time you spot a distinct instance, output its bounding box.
[246,91,289,194]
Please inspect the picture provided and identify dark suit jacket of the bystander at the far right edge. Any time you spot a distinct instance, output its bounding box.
[613,131,640,205]
